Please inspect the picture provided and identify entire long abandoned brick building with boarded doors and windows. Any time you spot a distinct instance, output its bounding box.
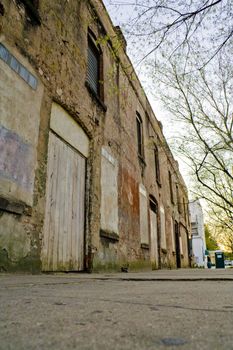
[0,0,190,272]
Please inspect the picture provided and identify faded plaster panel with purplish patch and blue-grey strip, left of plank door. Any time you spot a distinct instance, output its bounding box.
[0,44,43,206]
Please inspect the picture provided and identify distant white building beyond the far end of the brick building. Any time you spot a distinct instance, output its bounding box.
[189,200,206,267]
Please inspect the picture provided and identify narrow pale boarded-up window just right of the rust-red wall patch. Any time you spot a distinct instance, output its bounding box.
[139,184,149,244]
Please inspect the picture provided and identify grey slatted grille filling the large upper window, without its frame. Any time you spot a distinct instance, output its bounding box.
[87,35,101,96]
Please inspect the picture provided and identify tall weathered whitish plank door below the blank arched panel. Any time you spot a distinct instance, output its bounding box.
[42,132,86,271]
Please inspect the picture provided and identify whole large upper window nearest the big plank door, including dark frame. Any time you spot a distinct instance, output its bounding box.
[87,33,104,101]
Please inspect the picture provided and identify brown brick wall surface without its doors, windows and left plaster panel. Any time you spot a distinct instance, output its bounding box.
[0,0,189,270]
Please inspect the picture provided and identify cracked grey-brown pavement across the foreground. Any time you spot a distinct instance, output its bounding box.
[0,269,233,350]
